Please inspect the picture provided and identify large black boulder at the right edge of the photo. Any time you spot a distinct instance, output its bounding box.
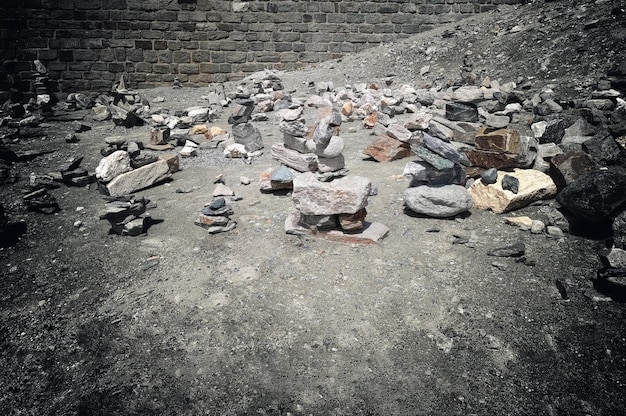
[556,170,626,222]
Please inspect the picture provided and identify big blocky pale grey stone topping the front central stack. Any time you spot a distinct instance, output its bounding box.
[292,172,372,215]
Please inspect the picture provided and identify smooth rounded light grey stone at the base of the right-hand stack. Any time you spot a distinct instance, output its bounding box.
[403,185,473,218]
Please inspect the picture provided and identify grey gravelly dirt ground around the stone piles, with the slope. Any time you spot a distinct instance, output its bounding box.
[0,1,626,415]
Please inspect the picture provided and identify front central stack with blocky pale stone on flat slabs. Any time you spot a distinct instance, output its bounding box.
[285,172,389,244]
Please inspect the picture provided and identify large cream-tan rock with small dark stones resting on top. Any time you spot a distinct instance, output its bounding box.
[469,169,556,214]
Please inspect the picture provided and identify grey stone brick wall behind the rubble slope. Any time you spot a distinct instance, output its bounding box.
[0,0,524,98]
